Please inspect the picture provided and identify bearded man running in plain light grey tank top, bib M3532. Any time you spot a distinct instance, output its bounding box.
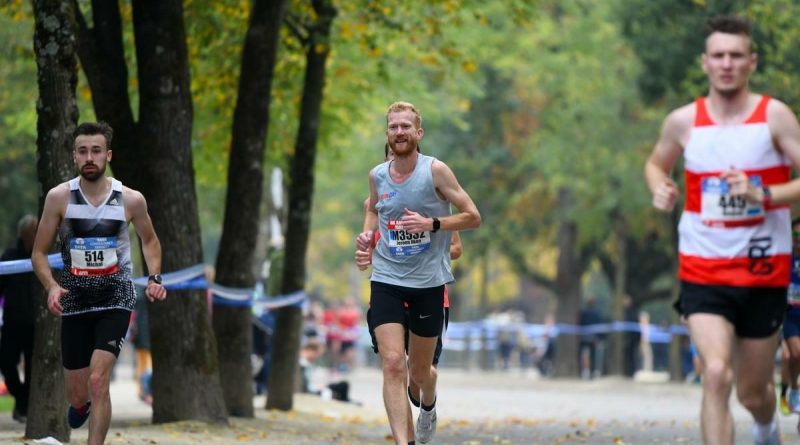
[356,102,481,445]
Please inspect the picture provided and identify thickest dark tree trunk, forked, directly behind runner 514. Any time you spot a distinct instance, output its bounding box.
[79,0,226,422]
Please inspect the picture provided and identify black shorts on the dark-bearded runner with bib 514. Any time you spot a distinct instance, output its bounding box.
[61,309,131,370]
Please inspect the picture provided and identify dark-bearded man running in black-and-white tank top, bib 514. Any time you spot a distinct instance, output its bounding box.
[31,122,167,445]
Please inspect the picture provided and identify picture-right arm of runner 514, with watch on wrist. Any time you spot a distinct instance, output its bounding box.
[123,187,167,301]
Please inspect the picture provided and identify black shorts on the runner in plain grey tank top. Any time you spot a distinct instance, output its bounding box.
[367,281,444,337]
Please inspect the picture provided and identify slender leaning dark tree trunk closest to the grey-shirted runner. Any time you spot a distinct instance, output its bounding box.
[267,0,336,411]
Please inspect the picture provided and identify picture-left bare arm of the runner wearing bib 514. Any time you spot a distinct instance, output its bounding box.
[31,184,69,315]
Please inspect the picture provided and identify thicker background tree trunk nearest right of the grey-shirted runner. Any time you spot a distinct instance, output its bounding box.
[553,188,583,377]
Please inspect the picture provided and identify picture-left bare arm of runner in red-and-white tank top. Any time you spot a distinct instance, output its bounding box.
[644,107,692,211]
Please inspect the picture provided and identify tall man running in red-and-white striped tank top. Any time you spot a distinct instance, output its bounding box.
[645,16,800,445]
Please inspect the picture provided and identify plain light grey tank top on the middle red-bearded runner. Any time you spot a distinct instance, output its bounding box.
[371,154,453,288]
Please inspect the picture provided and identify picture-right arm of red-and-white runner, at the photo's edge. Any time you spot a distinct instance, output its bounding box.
[767,99,800,204]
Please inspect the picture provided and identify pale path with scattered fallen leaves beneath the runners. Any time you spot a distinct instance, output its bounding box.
[0,369,800,445]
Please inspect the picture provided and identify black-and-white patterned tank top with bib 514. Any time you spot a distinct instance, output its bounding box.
[58,177,136,316]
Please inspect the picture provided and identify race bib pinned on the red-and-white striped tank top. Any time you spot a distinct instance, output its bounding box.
[700,175,764,227]
